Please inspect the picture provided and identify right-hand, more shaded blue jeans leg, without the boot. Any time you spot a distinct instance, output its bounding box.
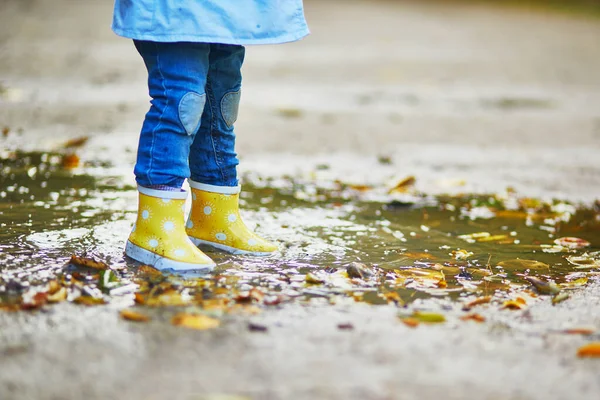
[189,44,245,186]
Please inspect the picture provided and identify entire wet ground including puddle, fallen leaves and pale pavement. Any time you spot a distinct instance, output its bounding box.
[0,1,600,400]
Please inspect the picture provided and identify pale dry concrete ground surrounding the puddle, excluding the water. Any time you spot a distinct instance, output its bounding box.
[0,0,600,400]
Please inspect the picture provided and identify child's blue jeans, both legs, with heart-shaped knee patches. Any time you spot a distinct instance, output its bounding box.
[134,40,245,188]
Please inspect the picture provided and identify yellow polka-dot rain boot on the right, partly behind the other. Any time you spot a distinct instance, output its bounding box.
[186,180,277,256]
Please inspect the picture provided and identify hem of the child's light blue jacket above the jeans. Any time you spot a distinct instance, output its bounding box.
[112,0,309,45]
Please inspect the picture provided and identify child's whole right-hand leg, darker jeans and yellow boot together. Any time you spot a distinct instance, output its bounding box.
[187,44,277,255]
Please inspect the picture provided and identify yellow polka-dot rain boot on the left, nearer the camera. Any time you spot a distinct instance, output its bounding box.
[125,186,215,271]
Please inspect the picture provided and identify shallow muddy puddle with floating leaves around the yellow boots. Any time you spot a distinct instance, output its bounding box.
[0,153,600,304]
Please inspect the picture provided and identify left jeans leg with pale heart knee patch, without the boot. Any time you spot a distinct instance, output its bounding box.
[134,41,211,188]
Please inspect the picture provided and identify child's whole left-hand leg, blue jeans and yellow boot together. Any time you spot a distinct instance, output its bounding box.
[125,41,215,270]
